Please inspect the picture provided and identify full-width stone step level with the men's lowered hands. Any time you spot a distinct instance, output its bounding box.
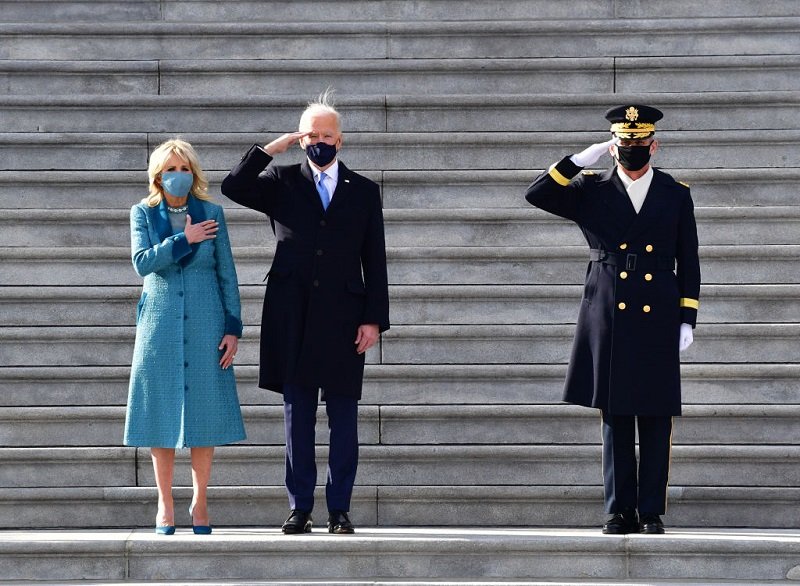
[0,320,800,366]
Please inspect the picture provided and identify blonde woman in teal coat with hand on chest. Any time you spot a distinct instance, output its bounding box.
[125,140,245,535]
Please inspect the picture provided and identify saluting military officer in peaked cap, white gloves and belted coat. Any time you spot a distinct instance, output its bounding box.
[525,105,700,534]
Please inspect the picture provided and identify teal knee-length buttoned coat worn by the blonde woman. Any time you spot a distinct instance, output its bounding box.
[125,195,245,448]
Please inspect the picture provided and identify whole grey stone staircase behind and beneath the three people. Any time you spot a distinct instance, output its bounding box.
[0,0,800,584]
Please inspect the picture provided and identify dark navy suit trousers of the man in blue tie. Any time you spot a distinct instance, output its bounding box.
[283,385,358,511]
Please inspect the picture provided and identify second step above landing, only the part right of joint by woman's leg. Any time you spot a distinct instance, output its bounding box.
[131,445,800,487]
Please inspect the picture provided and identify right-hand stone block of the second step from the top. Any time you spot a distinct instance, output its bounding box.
[388,15,798,58]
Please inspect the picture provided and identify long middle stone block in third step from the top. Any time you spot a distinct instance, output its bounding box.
[159,57,612,97]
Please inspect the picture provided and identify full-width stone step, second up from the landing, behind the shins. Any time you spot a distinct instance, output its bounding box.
[0,442,800,488]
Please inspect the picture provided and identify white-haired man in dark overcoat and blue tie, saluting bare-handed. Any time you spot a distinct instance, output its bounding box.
[222,95,389,533]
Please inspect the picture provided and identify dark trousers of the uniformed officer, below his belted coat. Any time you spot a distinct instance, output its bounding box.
[603,413,672,515]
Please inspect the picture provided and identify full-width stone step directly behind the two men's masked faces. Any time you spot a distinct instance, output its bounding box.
[0,130,800,171]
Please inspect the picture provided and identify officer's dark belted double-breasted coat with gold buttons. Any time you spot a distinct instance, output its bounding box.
[525,157,700,415]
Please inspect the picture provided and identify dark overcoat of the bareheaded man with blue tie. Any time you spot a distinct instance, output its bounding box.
[222,145,389,398]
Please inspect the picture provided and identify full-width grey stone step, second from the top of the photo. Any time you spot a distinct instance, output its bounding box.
[0,14,800,60]
